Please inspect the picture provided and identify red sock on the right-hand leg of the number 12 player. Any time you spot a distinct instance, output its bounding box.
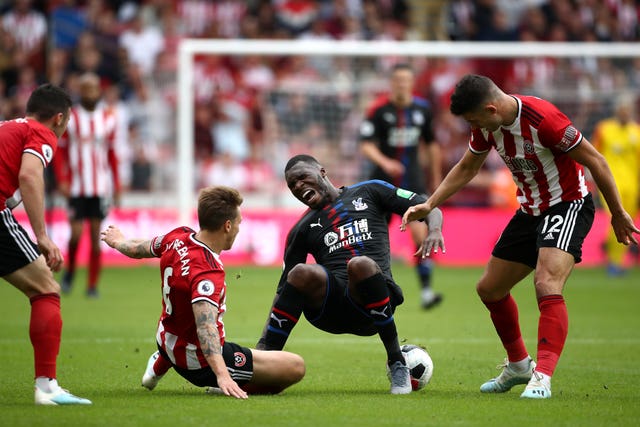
[536,295,569,376]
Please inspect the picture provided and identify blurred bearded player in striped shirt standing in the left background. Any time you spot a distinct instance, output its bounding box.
[54,73,120,297]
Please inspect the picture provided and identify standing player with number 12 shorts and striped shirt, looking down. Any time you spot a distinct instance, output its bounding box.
[402,75,640,399]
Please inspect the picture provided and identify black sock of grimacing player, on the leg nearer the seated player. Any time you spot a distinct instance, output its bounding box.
[264,282,304,350]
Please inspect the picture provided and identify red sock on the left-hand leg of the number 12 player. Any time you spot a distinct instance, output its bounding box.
[483,294,529,362]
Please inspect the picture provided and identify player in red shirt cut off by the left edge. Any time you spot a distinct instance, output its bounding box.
[0,84,91,405]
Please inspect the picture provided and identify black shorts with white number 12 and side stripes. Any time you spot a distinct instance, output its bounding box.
[491,194,595,268]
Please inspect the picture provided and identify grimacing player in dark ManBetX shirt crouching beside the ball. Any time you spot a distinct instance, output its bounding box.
[257,155,444,394]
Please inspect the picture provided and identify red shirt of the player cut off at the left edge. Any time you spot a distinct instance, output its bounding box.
[0,118,58,210]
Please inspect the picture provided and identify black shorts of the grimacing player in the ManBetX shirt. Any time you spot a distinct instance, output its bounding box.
[304,269,404,336]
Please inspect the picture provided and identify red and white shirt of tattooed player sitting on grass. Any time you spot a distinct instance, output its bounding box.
[151,227,227,369]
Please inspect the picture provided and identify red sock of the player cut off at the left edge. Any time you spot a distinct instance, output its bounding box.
[29,293,62,378]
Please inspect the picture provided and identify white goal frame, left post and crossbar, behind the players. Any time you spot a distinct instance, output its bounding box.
[175,39,640,224]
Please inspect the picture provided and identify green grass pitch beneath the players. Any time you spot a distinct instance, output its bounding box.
[0,264,640,427]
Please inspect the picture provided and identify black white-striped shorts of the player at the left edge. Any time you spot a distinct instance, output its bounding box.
[0,208,40,277]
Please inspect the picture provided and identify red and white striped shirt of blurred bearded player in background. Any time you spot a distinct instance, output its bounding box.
[55,104,120,197]
